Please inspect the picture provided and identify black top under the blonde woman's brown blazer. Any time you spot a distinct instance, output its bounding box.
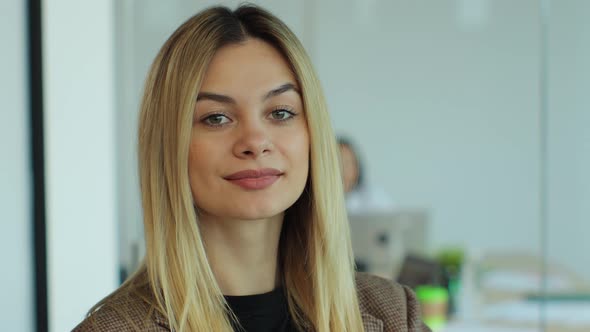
[225,288,296,332]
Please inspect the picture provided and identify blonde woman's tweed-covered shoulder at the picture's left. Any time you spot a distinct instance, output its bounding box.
[72,286,169,332]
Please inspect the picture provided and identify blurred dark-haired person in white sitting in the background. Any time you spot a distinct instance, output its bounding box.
[337,136,394,214]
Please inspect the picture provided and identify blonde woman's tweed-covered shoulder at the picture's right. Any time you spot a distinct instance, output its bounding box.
[356,272,430,331]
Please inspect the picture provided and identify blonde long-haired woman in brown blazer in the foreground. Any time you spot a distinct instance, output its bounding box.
[74,6,426,332]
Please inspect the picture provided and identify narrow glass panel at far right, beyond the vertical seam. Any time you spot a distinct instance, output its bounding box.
[541,0,590,331]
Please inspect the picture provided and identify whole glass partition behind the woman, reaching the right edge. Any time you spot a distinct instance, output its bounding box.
[117,0,590,332]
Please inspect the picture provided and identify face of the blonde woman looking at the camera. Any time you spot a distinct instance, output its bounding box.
[188,39,309,219]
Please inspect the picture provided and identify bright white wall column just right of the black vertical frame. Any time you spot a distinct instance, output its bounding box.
[42,0,118,332]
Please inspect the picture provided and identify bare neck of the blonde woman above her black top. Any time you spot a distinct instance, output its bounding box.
[199,214,283,295]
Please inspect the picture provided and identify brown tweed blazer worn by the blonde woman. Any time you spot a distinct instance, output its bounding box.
[73,273,430,332]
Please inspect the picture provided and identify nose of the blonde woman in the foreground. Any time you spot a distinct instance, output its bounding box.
[233,123,273,159]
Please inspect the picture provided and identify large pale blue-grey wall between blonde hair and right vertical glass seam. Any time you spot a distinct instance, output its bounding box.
[315,0,540,252]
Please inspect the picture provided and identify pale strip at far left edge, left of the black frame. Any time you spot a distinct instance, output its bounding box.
[0,0,35,332]
